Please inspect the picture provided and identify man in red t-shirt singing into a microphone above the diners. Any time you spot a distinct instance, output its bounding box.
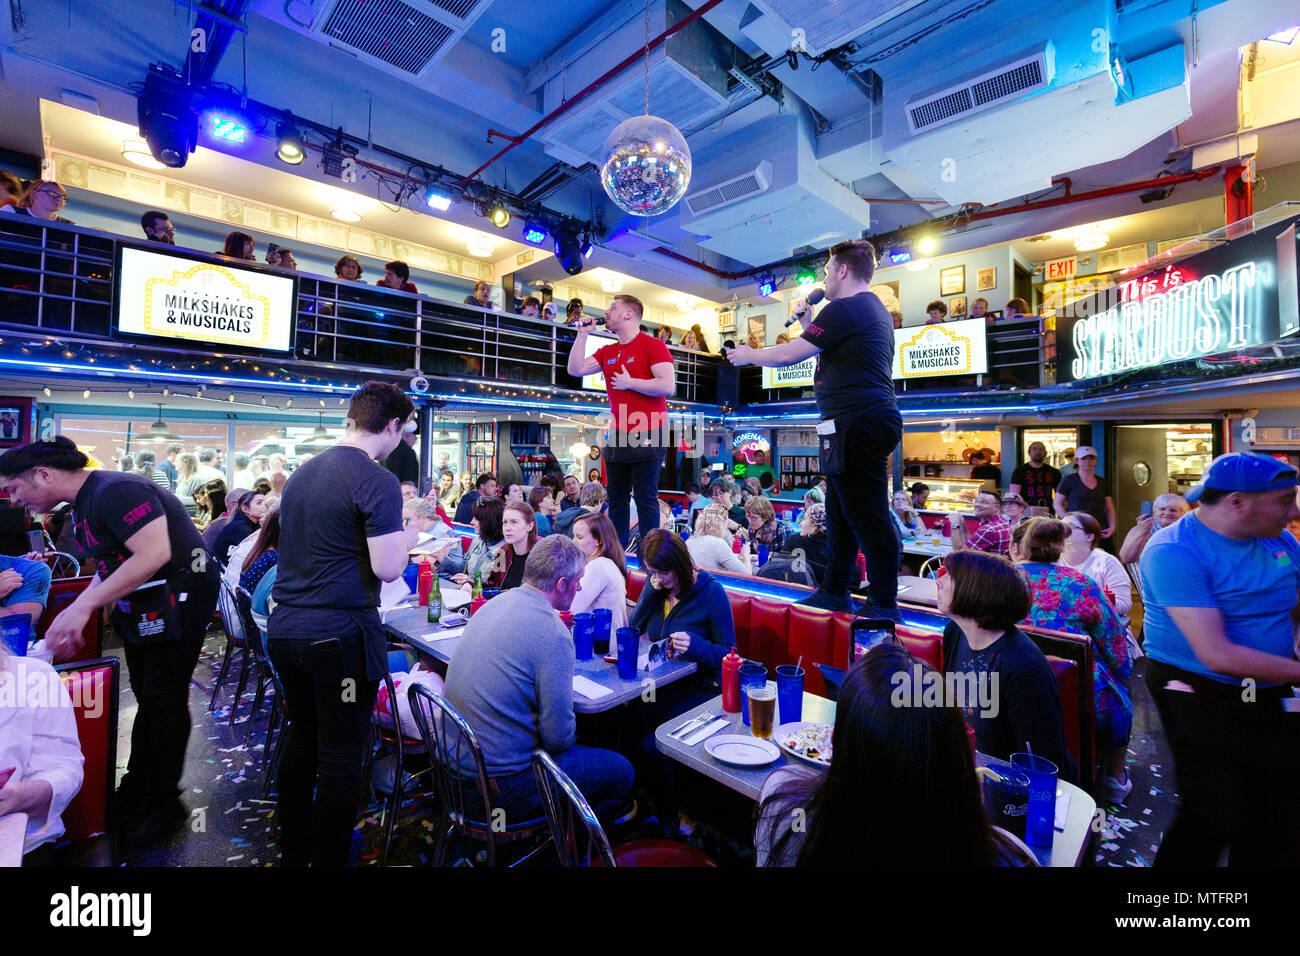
[568,295,676,545]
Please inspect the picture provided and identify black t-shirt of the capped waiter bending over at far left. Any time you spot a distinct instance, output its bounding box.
[73,471,207,580]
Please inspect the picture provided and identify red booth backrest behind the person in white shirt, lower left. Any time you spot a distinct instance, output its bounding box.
[55,657,121,840]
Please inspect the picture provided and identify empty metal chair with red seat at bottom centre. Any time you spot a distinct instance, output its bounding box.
[533,750,718,866]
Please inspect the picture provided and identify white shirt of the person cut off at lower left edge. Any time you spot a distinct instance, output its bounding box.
[0,657,83,853]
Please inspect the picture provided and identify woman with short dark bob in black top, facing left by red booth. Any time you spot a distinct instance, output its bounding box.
[937,550,1075,780]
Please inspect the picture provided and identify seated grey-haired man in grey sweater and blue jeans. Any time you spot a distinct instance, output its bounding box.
[443,538,633,826]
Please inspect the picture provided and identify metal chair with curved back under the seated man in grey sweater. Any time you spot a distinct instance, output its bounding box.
[407,684,547,866]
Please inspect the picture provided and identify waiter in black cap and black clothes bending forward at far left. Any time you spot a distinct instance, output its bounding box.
[0,436,218,853]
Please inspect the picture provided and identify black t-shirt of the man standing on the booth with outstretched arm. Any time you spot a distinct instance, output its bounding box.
[802,293,898,419]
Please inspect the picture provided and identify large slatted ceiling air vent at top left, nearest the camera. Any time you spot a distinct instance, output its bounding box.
[312,0,491,78]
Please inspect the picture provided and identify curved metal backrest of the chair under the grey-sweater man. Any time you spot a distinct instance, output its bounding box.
[407,683,497,866]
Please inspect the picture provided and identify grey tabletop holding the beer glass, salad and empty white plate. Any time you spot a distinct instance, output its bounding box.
[654,697,1097,866]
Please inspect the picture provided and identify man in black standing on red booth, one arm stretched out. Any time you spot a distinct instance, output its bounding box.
[727,239,902,620]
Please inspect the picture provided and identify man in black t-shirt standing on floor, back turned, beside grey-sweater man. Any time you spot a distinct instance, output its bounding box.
[267,381,419,866]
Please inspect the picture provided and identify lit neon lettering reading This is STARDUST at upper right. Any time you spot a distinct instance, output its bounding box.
[1070,261,1269,378]
